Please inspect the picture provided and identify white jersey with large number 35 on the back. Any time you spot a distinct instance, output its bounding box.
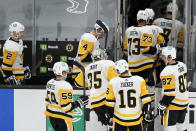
[75,60,118,109]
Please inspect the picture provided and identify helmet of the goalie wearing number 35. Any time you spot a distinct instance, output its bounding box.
[91,48,107,61]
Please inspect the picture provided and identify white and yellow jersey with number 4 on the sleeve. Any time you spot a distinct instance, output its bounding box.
[73,33,100,77]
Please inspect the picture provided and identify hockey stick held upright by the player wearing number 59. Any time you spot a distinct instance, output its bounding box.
[73,60,86,131]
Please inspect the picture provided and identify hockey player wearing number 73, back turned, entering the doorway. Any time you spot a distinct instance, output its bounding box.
[124,10,165,86]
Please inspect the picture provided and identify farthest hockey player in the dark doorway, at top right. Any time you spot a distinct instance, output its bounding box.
[153,2,184,61]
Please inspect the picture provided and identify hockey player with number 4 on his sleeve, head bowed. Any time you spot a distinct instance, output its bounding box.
[72,20,109,78]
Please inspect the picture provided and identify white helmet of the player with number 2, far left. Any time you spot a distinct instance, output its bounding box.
[9,22,25,33]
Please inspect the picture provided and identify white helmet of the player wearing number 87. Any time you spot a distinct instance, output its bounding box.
[161,46,176,59]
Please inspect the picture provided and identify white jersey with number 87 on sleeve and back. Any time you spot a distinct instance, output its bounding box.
[160,61,188,110]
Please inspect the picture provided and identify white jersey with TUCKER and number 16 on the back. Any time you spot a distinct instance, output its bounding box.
[106,75,151,126]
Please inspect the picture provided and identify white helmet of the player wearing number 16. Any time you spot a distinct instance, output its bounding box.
[114,59,129,74]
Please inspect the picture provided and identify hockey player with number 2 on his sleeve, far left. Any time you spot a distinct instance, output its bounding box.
[1,22,31,85]
